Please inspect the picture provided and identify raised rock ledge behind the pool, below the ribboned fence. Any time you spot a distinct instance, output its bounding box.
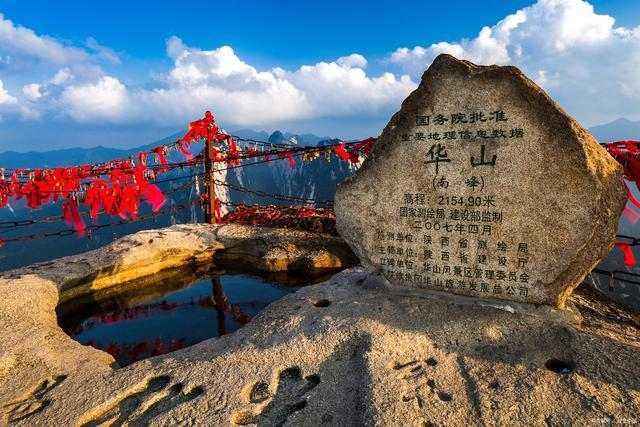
[0,224,357,302]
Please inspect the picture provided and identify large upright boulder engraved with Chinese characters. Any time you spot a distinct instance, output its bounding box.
[335,55,626,306]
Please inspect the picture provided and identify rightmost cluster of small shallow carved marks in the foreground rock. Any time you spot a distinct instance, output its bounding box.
[391,357,453,408]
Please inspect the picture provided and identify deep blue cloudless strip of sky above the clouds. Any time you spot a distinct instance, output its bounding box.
[2,0,531,67]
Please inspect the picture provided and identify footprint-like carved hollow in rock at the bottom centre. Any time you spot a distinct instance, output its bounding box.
[231,367,320,426]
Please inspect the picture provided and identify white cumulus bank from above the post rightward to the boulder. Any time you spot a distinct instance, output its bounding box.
[144,41,415,125]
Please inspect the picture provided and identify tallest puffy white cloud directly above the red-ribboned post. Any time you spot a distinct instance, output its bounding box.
[133,37,309,125]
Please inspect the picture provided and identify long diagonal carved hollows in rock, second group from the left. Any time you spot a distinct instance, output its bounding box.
[83,375,204,427]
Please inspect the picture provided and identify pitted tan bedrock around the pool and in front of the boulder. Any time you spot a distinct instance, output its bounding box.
[0,227,640,426]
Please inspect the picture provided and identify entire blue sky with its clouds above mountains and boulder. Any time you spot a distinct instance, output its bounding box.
[0,0,640,151]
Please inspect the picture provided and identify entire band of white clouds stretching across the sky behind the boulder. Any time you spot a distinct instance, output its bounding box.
[0,0,640,133]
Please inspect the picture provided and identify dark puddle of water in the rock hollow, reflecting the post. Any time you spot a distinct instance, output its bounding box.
[56,273,324,366]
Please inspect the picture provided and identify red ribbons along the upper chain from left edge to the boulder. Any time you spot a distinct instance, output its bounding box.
[0,111,375,241]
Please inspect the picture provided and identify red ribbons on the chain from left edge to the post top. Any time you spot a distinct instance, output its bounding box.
[0,111,225,233]
